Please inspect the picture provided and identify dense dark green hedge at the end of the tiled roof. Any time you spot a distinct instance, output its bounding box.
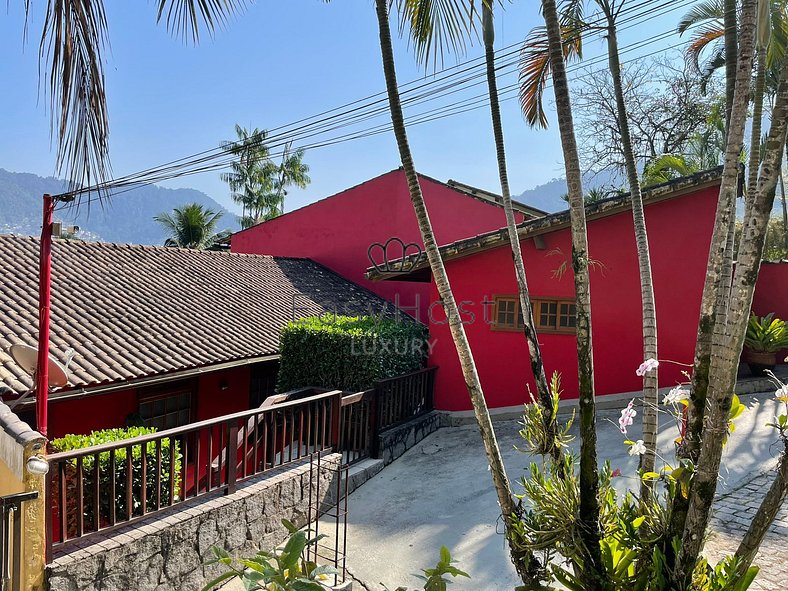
[277,314,429,392]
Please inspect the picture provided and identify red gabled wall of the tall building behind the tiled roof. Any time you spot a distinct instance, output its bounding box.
[230,169,523,319]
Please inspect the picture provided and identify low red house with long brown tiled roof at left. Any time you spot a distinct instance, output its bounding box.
[0,235,390,438]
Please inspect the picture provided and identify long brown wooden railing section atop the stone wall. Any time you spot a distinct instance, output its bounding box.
[47,390,342,556]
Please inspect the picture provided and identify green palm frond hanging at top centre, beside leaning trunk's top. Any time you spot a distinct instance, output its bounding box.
[397,0,484,67]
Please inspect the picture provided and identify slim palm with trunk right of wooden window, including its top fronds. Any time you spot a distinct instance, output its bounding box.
[520,0,659,495]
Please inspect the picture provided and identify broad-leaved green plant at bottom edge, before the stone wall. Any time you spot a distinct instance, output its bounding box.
[203,519,337,591]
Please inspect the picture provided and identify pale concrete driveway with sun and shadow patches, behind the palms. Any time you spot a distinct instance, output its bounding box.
[347,391,779,591]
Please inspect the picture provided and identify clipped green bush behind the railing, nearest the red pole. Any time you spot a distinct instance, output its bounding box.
[51,427,181,535]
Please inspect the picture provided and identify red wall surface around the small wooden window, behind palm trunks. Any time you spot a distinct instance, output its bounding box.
[430,188,717,410]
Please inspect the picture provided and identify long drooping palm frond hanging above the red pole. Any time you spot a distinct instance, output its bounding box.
[37,0,110,192]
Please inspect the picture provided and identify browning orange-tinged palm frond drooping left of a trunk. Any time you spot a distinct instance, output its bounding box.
[520,21,583,128]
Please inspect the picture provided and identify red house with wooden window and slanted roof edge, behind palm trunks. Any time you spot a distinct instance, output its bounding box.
[370,170,720,410]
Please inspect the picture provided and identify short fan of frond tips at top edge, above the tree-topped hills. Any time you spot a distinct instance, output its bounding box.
[156,0,246,43]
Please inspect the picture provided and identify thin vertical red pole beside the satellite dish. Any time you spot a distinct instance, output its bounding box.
[36,193,55,437]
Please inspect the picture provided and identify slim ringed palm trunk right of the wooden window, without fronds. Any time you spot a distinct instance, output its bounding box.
[602,9,659,498]
